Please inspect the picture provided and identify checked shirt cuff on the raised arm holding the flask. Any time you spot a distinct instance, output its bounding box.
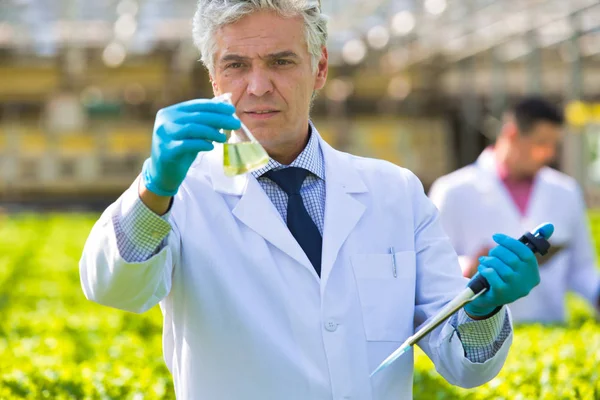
[112,181,171,262]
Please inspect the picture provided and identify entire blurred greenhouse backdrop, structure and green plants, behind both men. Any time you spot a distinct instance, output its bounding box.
[0,0,600,400]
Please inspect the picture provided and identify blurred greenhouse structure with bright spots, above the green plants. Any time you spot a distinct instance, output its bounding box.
[0,0,600,209]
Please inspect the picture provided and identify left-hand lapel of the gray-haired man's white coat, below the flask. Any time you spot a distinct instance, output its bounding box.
[210,146,317,278]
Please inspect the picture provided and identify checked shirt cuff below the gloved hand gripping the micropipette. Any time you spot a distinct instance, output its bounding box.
[450,306,512,363]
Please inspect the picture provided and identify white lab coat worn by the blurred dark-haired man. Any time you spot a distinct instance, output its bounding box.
[429,149,600,322]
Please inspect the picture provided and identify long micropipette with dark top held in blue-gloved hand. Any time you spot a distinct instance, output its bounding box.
[371,223,554,377]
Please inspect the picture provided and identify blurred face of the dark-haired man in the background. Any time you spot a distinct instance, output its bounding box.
[513,121,561,176]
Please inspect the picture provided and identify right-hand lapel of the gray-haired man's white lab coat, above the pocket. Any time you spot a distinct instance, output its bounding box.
[319,138,368,291]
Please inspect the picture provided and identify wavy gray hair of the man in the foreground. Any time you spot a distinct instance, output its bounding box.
[193,0,327,75]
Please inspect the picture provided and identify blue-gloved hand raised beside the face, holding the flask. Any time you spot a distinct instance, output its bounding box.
[142,99,240,196]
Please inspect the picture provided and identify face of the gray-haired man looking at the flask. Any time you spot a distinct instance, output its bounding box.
[211,11,327,155]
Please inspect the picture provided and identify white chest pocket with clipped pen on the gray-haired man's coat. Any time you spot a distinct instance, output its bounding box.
[351,251,416,342]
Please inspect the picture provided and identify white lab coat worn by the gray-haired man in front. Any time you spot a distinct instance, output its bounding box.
[80,139,512,400]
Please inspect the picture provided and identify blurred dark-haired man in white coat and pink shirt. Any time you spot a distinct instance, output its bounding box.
[429,97,600,323]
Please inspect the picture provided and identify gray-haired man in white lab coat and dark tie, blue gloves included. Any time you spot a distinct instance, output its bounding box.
[80,0,539,400]
